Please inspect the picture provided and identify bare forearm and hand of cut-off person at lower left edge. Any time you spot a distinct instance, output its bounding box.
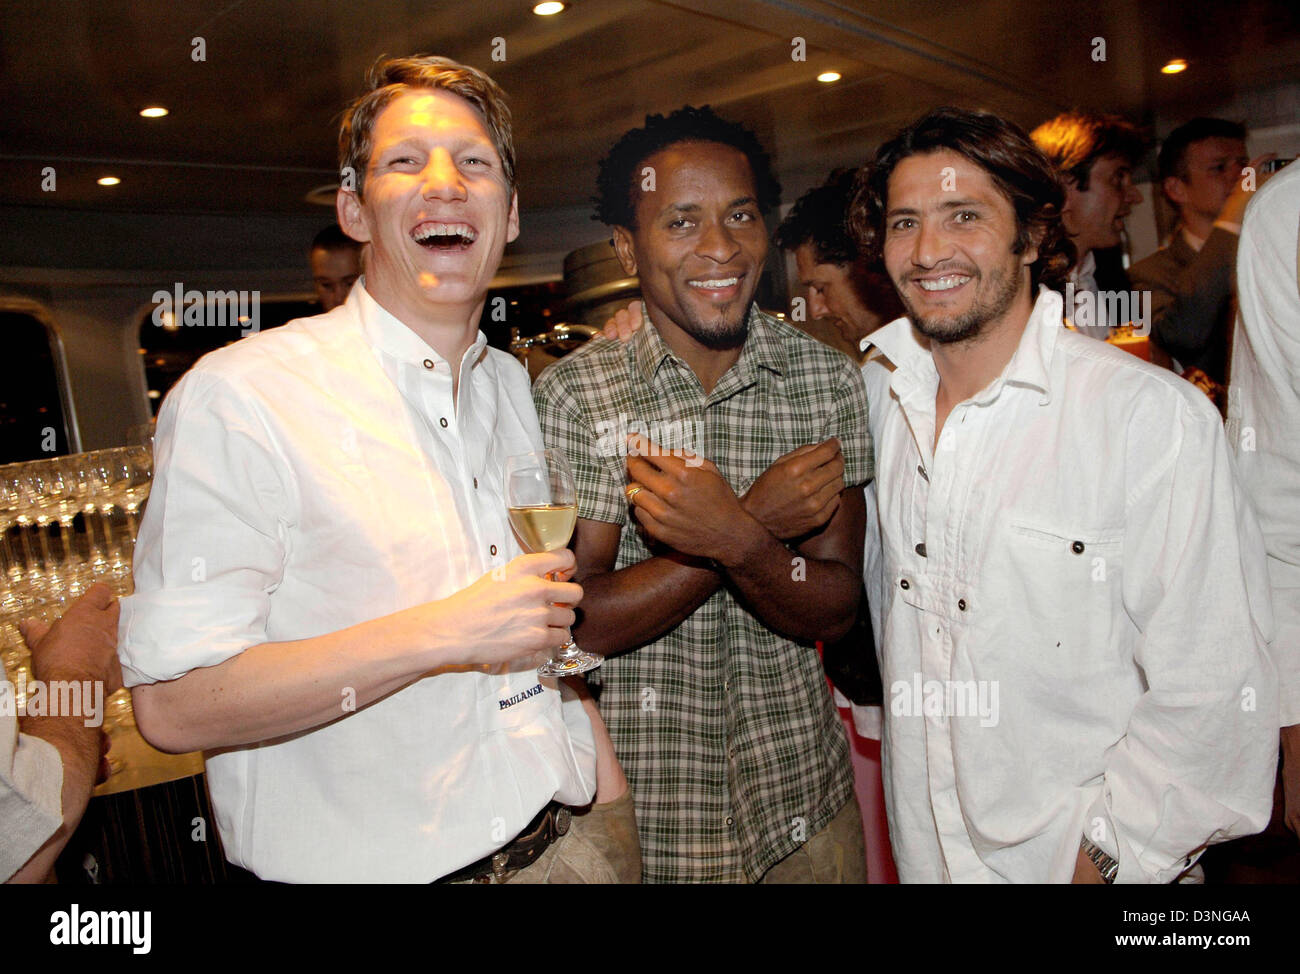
[8,584,122,883]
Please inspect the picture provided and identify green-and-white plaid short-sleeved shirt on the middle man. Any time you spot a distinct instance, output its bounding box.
[533,308,874,882]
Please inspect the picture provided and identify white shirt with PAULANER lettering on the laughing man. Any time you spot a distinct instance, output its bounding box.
[120,283,595,882]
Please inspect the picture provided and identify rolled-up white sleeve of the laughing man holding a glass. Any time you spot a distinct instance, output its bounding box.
[118,371,293,687]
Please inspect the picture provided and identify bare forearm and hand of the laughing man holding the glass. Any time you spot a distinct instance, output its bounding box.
[131,550,582,753]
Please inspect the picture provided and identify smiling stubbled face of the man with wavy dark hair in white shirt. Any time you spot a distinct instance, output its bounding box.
[884,150,1037,343]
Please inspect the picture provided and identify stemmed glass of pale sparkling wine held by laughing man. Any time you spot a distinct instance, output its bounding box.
[506,450,603,676]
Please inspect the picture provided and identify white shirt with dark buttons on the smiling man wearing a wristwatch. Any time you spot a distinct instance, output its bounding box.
[871,290,1277,882]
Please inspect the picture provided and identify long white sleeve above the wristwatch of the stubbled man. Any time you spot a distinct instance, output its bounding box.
[1086,395,1278,883]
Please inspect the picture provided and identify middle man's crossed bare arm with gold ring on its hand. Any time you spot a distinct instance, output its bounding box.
[628,443,866,642]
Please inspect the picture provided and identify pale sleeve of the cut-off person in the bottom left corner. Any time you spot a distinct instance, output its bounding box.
[0,712,64,883]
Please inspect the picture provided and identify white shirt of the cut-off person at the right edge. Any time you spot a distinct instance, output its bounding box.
[1229,164,1300,727]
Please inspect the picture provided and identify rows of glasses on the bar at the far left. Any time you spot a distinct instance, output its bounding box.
[0,446,153,718]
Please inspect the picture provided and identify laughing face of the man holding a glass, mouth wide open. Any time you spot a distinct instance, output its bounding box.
[338,88,519,322]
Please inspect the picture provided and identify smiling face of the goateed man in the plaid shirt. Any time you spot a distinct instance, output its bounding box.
[614,142,767,350]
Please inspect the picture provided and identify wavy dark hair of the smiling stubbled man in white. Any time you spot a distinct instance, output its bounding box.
[849,108,1076,290]
